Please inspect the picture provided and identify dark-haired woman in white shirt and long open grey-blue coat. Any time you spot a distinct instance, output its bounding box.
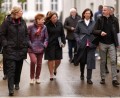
[74,8,96,84]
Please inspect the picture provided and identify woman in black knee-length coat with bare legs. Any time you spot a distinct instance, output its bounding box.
[45,12,66,81]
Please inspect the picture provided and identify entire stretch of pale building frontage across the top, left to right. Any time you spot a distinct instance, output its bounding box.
[2,0,120,22]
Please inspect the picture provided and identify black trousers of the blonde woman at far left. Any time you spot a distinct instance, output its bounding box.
[6,59,23,91]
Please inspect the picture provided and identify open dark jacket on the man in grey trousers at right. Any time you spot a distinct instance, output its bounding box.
[93,16,119,47]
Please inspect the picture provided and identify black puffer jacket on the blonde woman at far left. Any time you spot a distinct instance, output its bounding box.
[0,15,28,60]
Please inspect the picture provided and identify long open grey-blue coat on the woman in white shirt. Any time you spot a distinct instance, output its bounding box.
[74,20,96,69]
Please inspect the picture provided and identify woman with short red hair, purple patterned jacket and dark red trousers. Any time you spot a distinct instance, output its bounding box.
[28,14,48,84]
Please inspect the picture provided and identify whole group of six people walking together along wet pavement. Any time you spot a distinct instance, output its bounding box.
[0,6,119,96]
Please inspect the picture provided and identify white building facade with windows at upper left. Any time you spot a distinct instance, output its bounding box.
[2,0,63,20]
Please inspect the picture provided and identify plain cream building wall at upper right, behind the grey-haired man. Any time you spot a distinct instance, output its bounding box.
[63,0,120,21]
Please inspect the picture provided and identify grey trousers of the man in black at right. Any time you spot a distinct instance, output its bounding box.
[99,43,117,80]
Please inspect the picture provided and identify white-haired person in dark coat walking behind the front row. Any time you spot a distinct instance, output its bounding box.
[64,8,81,62]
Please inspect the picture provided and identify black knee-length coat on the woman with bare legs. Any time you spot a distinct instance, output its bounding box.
[45,21,66,60]
